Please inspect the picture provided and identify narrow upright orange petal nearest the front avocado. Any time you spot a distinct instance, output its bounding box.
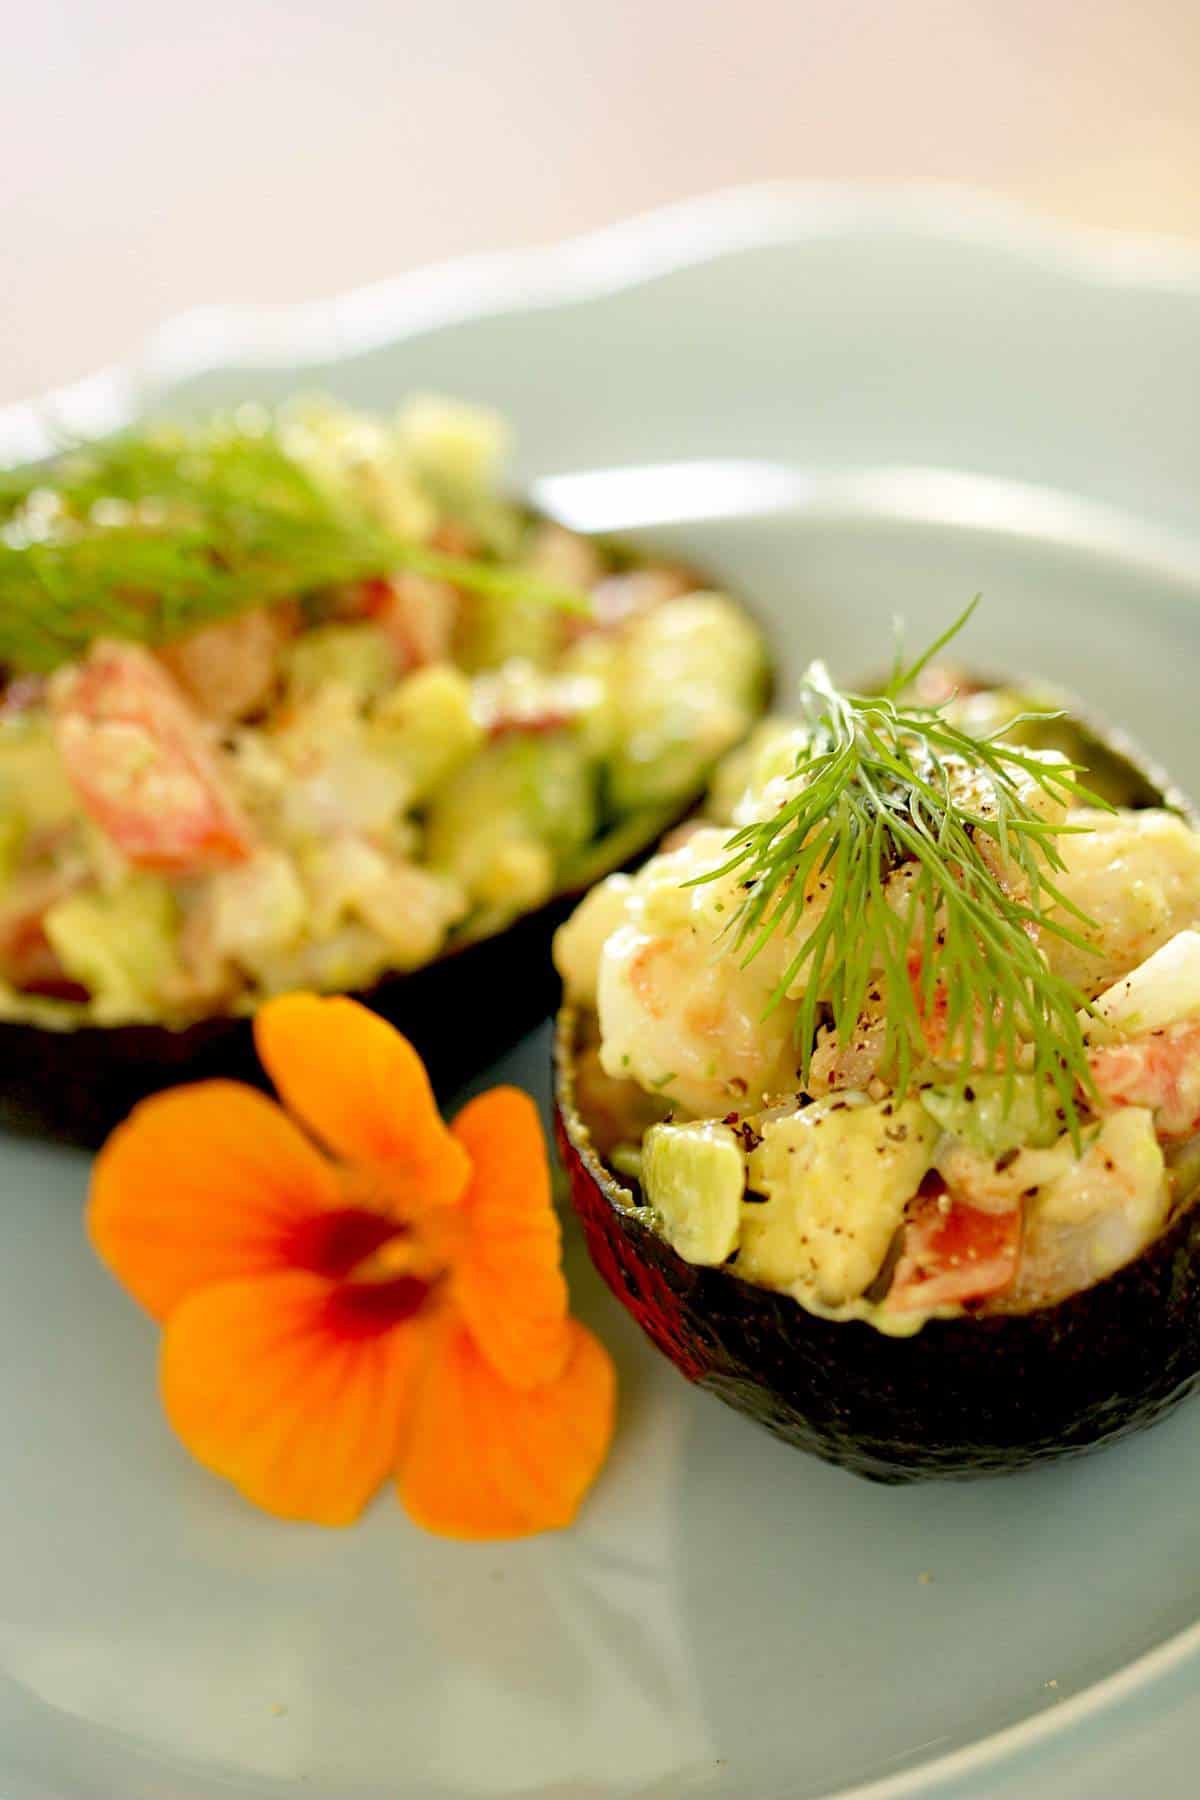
[452,1087,567,1388]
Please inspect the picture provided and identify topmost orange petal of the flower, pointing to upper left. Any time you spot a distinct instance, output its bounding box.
[254,994,470,1208]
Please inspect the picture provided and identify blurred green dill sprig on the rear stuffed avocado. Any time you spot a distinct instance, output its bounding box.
[0,419,587,673]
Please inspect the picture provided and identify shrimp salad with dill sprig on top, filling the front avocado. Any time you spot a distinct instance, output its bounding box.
[556,608,1200,1336]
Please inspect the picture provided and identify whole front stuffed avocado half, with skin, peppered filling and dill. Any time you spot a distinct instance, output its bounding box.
[556,619,1200,1481]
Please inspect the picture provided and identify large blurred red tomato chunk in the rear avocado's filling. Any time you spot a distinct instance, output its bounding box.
[50,643,252,875]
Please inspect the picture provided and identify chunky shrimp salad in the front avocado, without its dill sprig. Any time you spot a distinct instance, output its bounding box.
[556,670,1200,1336]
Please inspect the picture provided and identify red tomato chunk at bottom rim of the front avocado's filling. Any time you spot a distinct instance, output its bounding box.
[887,1193,1020,1312]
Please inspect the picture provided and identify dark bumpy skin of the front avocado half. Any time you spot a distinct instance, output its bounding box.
[558,1010,1200,1483]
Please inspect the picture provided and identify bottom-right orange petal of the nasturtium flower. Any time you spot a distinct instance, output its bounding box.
[399,1312,615,1539]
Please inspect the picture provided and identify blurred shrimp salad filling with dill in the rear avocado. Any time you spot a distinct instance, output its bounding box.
[0,401,765,1028]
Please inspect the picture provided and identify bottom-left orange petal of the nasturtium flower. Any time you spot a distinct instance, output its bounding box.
[160,1273,428,1525]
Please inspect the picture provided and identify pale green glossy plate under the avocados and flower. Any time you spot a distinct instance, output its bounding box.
[0,189,1200,1800]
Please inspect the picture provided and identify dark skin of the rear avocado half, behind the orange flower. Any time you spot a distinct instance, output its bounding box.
[0,895,578,1147]
